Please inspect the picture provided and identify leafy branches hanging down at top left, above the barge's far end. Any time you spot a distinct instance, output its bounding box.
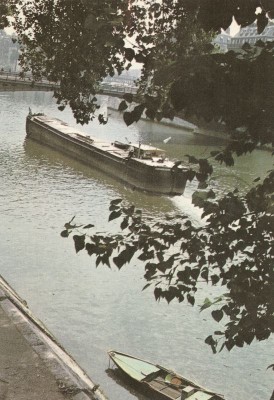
[11,0,130,124]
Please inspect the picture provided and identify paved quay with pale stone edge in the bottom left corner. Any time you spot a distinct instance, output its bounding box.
[0,276,107,400]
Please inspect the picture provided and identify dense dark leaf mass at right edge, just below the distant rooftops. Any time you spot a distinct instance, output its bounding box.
[142,42,274,155]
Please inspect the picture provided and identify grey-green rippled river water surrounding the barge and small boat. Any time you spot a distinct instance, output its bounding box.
[0,92,273,400]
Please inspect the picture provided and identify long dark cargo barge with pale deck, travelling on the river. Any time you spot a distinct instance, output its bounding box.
[26,114,186,195]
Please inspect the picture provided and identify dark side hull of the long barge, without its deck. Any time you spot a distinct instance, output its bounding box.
[26,116,186,195]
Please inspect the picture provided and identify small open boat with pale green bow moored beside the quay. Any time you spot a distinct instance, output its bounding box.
[108,350,224,400]
